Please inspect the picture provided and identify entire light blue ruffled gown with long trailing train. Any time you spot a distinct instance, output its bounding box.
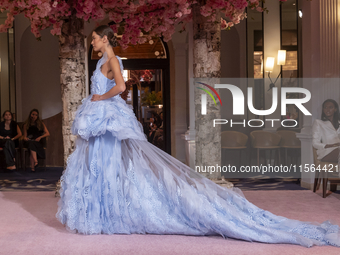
[56,53,340,247]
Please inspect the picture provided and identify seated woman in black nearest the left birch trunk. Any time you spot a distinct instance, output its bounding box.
[23,109,50,172]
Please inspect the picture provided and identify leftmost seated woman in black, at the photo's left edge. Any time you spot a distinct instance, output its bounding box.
[0,111,22,170]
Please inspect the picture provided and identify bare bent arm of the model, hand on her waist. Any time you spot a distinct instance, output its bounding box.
[91,57,126,101]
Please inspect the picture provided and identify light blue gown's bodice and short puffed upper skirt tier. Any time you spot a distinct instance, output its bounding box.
[72,52,147,140]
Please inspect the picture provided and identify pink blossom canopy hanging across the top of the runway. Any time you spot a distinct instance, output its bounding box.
[0,0,286,48]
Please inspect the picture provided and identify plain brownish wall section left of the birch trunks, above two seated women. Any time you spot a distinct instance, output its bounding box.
[15,15,62,121]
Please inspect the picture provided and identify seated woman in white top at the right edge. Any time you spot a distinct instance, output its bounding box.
[313,99,340,162]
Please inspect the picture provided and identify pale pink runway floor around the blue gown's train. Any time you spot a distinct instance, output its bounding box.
[0,190,340,255]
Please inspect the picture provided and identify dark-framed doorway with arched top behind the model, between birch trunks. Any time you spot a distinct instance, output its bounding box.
[88,38,171,154]
